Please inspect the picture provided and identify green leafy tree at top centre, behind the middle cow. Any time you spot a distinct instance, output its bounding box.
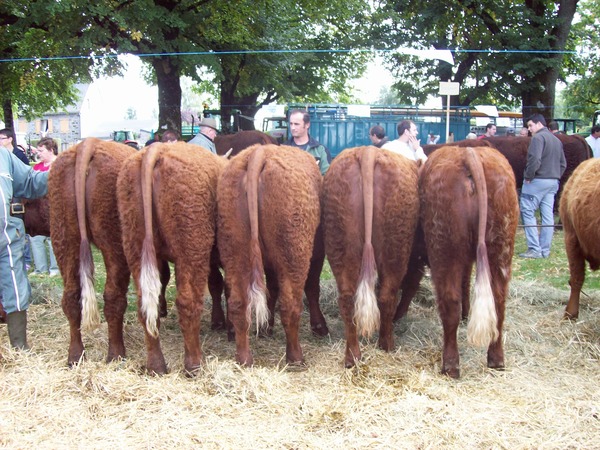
[202,0,369,133]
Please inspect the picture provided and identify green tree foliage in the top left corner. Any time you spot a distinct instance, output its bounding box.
[0,1,101,128]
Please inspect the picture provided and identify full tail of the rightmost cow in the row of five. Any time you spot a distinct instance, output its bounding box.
[466,147,498,347]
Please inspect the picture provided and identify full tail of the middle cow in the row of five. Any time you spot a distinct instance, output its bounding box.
[246,146,269,331]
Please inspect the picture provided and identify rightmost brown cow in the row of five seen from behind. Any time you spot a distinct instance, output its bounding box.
[419,147,519,378]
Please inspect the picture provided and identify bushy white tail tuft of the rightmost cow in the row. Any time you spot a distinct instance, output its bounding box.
[467,266,499,347]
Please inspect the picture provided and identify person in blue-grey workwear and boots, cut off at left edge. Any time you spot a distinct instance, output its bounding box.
[0,135,49,349]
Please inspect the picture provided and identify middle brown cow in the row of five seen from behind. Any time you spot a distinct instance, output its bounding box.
[218,145,321,366]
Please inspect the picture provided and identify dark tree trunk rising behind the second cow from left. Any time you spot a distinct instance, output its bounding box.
[152,56,181,134]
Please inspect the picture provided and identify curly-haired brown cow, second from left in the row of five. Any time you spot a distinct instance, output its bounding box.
[117,143,226,374]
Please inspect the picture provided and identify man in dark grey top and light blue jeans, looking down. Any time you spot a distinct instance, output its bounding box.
[519,114,567,258]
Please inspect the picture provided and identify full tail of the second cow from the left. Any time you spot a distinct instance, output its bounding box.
[140,145,161,338]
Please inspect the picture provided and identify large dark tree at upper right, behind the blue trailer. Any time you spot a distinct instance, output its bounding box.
[377,0,577,118]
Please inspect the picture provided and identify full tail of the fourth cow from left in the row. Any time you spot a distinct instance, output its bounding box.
[354,147,380,336]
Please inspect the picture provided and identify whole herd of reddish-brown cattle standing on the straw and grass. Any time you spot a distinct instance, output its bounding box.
[25,132,600,378]
